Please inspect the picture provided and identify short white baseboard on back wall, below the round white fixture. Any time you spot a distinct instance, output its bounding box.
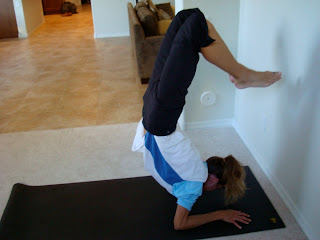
[179,118,233,130]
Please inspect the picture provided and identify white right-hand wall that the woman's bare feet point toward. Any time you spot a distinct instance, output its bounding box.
[235,0,320,240]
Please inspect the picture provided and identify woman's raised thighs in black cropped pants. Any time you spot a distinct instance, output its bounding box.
[142,9,214,136]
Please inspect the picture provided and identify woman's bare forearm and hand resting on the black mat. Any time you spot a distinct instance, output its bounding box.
[174,205,251,230]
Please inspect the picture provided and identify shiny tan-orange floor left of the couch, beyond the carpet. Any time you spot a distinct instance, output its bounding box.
[0,5,147,133]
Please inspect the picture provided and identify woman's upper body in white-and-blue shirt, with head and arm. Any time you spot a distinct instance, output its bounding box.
[132,120,251,230]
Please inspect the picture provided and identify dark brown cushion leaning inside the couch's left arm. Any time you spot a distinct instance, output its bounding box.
[137,7,159,37]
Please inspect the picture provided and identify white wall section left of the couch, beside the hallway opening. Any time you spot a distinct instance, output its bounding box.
[91,0,135,38]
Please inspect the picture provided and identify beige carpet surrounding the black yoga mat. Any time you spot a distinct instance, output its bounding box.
[0,123,307,240]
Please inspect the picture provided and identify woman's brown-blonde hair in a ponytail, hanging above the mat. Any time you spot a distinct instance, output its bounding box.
[207,155,246,205]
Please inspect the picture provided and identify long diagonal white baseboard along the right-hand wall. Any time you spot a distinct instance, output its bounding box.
[233,121,319,240]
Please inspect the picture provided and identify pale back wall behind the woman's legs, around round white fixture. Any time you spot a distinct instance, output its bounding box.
[176,0,240,129]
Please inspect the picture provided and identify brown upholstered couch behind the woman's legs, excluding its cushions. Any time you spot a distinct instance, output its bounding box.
[127,2,171,84]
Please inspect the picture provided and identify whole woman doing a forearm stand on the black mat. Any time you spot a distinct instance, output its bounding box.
[132,9,281,230]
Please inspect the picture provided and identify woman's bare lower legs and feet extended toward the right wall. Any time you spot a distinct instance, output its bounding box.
[201,20,281,88]
